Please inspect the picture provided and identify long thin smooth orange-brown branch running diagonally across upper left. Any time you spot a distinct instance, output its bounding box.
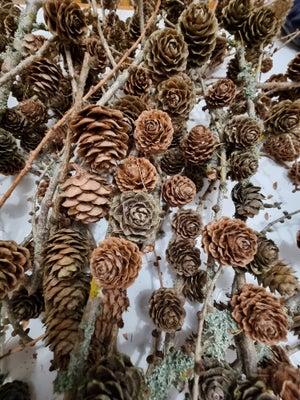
[0,0,160,208]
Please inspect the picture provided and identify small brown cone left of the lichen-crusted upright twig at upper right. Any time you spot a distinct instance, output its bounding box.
[204,78,236,109]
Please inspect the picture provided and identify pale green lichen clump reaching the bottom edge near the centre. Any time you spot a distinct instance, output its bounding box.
[147,349,194,400]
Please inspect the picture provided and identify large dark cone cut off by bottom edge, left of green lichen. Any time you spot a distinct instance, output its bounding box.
[80,353,146,400]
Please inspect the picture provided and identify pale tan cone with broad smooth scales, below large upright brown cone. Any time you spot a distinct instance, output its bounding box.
[61,165,114,224]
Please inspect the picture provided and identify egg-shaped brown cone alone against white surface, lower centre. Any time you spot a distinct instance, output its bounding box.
[149,287,186,333]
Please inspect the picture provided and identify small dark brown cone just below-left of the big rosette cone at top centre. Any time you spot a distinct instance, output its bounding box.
[123,67,152,98]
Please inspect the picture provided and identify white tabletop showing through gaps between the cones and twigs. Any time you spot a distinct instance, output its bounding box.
[0,8,300,400]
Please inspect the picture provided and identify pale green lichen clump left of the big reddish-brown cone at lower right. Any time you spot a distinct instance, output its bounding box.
[203,309,238,361]
